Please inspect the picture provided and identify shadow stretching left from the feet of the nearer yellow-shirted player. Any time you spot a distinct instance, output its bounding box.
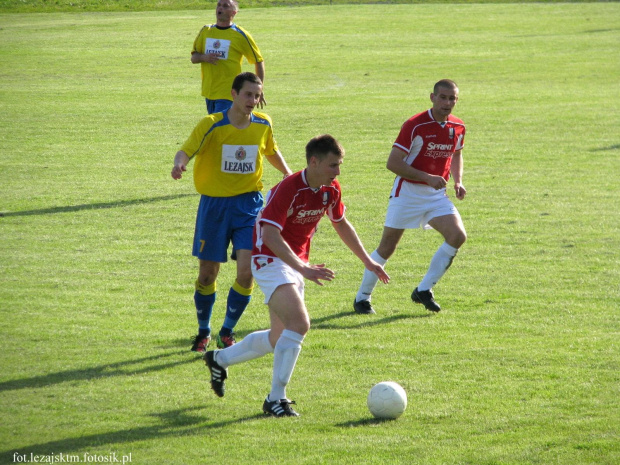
[0,350,197,392]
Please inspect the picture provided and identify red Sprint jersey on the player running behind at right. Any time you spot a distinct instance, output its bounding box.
[392,110,465,192]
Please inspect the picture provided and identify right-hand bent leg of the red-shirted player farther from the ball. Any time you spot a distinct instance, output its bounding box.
[411,212,467,312]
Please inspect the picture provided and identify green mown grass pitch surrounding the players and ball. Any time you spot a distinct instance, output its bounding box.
[0,3,620,465]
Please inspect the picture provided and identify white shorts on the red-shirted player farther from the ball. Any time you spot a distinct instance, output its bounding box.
[385,182,461,229]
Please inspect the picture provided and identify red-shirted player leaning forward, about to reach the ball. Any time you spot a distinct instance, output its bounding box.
[204,134,390,417]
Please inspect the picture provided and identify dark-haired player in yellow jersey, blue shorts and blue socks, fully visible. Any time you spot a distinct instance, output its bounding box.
[171,73,292,352]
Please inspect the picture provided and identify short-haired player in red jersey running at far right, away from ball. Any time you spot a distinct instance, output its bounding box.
[353,79,467,314]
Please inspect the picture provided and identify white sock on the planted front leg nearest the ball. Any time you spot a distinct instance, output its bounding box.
[268,329,304,402]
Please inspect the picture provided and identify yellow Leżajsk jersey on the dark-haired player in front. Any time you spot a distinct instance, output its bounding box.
[181,112,278,197]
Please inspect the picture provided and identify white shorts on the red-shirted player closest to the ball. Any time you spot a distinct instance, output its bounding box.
[252,255,305,304]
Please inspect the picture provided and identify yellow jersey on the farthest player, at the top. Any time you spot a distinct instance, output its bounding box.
[192,24,263,100]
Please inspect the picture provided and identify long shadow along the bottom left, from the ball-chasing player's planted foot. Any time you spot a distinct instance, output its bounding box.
[0,407,266,463]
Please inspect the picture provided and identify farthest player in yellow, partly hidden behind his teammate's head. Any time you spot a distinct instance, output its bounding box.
[192,0,265,114]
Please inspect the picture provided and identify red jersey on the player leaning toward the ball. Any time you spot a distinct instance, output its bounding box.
[252,170,346,263]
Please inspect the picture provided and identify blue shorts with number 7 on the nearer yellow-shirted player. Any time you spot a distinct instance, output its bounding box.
[192,192,263,263]
